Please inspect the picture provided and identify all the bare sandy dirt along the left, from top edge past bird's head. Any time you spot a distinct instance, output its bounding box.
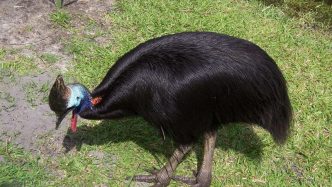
[0,0,112,156]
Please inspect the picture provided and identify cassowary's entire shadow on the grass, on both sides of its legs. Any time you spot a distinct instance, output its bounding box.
[63,118,263,169]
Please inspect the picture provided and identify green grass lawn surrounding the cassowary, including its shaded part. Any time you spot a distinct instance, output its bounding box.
[0,0,332,186]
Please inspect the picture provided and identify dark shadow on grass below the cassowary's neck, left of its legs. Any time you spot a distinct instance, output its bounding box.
[63,118,176,165]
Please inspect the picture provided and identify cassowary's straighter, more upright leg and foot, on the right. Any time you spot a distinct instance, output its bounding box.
[172,131,217,187]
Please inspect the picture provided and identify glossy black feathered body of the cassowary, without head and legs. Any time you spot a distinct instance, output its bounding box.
[92,32,291,143]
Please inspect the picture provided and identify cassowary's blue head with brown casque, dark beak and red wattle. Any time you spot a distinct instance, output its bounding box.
[49,75,92,132]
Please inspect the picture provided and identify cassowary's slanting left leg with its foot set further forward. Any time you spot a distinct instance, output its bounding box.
[133,145,192,186]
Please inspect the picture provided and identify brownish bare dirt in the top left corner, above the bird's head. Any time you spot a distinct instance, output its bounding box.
[0,0,72,71]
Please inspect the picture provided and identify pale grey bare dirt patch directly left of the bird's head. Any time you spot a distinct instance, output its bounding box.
[0,73,66,150]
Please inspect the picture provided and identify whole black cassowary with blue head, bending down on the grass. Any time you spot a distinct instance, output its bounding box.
[49,32,292,186]
